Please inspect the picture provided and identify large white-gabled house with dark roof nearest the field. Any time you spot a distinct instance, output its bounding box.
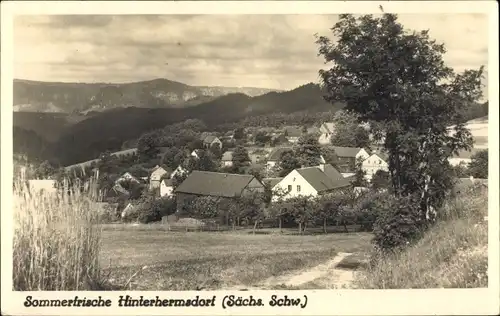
[272,164,351,201]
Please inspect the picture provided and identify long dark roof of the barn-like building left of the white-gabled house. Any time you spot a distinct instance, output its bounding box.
[176,170,262,197]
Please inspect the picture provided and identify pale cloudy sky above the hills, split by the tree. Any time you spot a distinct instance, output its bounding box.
[14,14,488,94]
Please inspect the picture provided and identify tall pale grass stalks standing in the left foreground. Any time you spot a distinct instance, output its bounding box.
[13,172,103,291]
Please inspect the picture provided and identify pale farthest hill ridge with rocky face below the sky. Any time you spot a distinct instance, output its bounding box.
[13,79,275,114]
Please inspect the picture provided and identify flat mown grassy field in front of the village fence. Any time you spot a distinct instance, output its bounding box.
[100,229,371,290]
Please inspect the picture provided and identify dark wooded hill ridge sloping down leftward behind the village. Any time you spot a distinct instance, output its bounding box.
[45,84,343,165]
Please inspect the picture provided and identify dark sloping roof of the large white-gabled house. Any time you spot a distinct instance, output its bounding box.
[296,165,350,192]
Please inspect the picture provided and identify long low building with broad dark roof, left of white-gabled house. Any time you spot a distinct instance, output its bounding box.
[175,170,264,210]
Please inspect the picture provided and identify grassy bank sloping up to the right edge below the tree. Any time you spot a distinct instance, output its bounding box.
[355,190,488,289]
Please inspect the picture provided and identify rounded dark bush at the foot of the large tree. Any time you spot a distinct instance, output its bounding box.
[373,196,427,252]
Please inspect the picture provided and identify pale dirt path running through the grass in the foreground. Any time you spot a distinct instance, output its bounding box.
[224,252,360,290]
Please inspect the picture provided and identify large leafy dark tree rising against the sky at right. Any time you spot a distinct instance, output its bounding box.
[317,14,483,218]
